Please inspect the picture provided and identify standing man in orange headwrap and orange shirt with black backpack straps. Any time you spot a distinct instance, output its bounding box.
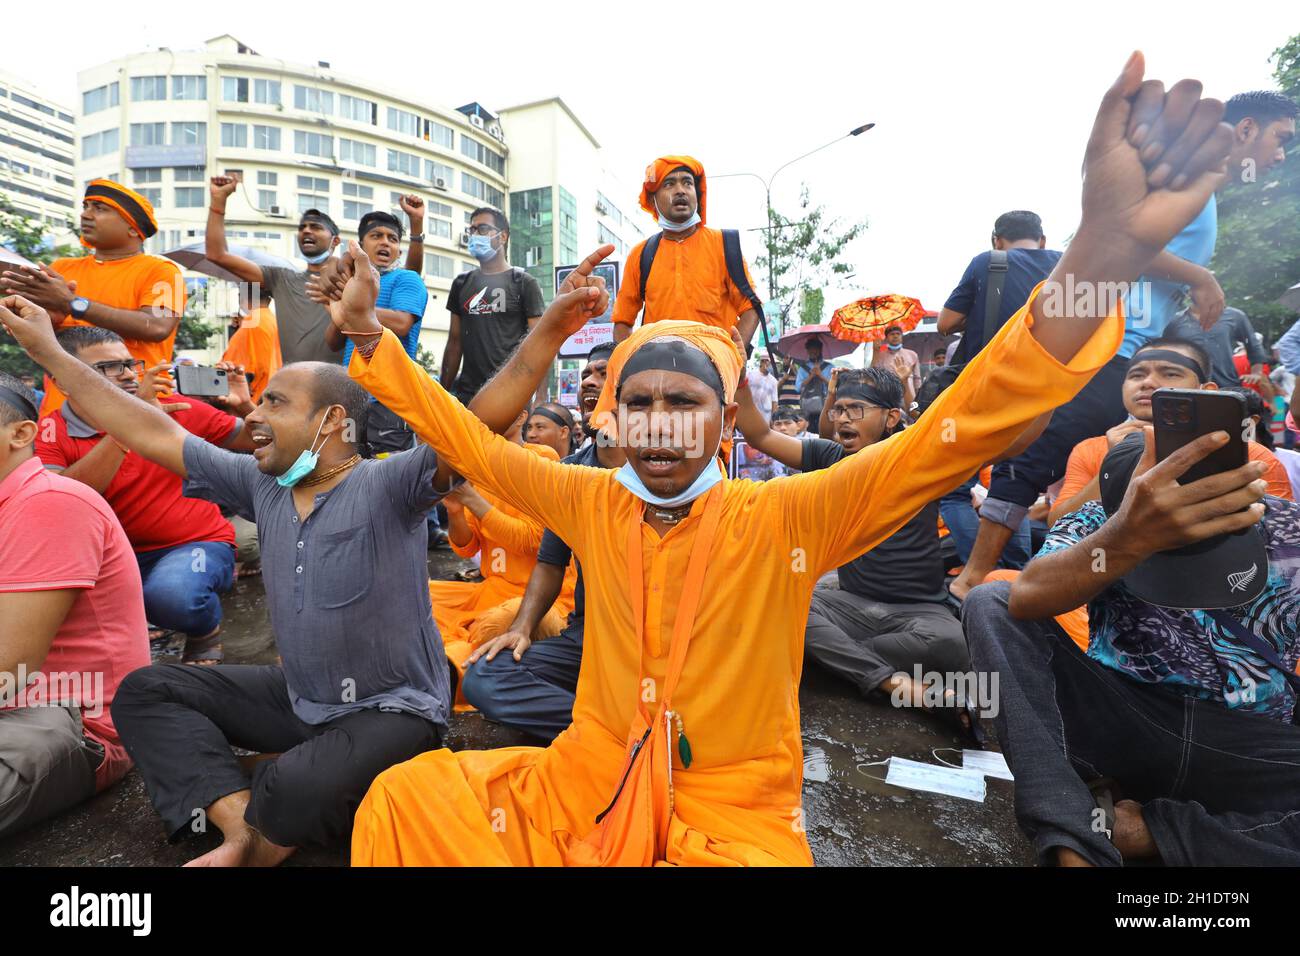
[614,156,758,346]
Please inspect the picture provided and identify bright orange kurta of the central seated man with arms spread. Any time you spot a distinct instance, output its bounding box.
[350,286,1123,866]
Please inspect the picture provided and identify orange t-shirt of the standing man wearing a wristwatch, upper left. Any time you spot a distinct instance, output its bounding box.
[40,252,185,416]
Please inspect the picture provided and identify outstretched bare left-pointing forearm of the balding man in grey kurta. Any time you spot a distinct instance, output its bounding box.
[0,295,191,477]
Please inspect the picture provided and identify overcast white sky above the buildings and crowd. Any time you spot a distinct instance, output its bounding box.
[5,0,1300,308]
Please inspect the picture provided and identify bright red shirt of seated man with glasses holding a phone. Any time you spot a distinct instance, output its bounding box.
[36,402,238,551]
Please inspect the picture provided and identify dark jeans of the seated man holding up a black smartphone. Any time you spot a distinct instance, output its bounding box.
[963,581,1300,866]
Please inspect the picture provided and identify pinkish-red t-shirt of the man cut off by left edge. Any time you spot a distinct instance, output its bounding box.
[0,458,150,791]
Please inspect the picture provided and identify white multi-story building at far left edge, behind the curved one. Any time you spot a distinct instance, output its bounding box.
[0,70,79,245]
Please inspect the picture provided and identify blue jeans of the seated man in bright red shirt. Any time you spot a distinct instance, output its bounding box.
[135,541,235,637]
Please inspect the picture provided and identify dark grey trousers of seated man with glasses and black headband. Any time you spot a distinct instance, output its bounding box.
[803,588,970,695]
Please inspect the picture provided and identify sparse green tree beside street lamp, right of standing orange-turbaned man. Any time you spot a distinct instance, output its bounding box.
[757,185,867,335]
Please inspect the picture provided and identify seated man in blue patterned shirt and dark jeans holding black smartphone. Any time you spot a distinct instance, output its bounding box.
[963,428,1300,866]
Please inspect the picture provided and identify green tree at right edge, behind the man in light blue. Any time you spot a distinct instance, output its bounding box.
[1212,34,1300,345]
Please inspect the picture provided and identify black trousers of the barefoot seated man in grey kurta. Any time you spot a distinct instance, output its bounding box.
[113,665,439,847]
